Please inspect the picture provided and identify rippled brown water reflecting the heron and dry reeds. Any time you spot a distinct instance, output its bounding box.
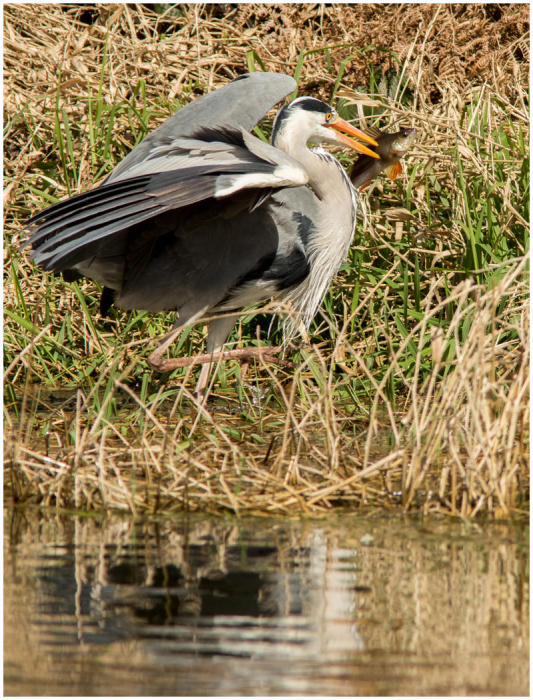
[4,511,529,696]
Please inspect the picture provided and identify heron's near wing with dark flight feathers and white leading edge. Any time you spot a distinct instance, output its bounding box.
[26,128,308,271]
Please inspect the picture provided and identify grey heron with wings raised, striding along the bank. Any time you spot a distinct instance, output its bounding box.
[25,73,379,395]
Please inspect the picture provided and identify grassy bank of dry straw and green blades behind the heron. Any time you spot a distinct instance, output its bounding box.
[4,5,529,517]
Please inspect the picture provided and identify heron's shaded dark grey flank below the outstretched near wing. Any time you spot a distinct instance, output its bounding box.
[115,187,316,323]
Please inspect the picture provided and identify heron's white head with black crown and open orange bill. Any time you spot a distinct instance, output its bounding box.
[272,97,379,158]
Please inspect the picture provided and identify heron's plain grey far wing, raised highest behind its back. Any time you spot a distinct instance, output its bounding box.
[106,73,296,183]
